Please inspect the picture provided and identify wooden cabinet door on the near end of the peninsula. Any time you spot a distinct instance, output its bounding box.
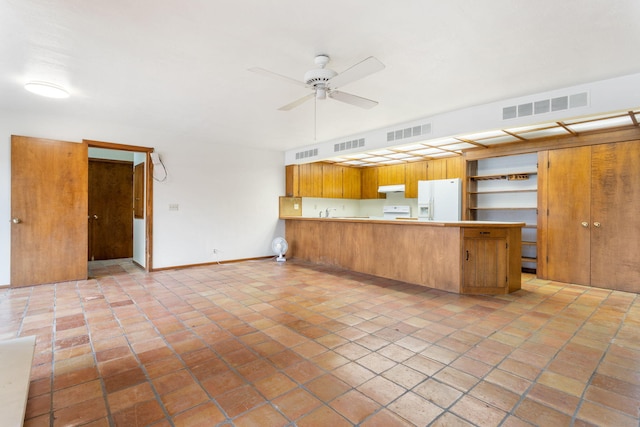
[462,230,509,294]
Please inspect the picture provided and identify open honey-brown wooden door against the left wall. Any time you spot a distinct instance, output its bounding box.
[11,136,87,287]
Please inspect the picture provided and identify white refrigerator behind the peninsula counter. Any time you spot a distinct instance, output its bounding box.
[418,178,462,221]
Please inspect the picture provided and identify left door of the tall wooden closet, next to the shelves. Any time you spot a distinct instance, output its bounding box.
[546,147,591,285]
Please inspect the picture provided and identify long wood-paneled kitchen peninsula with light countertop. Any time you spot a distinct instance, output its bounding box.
[281,216,525,295]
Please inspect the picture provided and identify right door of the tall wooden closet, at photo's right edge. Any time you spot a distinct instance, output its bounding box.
[590,141,640,292]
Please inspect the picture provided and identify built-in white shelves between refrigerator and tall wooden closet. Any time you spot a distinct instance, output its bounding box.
[466,153,538,272]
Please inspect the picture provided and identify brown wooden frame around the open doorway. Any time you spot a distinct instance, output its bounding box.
[82,139,154,272]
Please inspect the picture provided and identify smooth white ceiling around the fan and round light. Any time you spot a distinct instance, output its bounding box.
[0,0,640,150]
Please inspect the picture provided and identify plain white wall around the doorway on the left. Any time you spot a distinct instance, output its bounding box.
[0,111,284,285]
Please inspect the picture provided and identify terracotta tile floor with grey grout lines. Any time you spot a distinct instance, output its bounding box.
[0,260,640,427]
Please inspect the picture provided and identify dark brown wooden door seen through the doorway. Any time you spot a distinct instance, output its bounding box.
[88,159,133,260]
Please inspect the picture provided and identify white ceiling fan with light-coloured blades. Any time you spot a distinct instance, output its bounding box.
[249,55,384,111]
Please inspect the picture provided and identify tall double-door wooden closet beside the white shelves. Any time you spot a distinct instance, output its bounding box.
[538,141,640,292]
